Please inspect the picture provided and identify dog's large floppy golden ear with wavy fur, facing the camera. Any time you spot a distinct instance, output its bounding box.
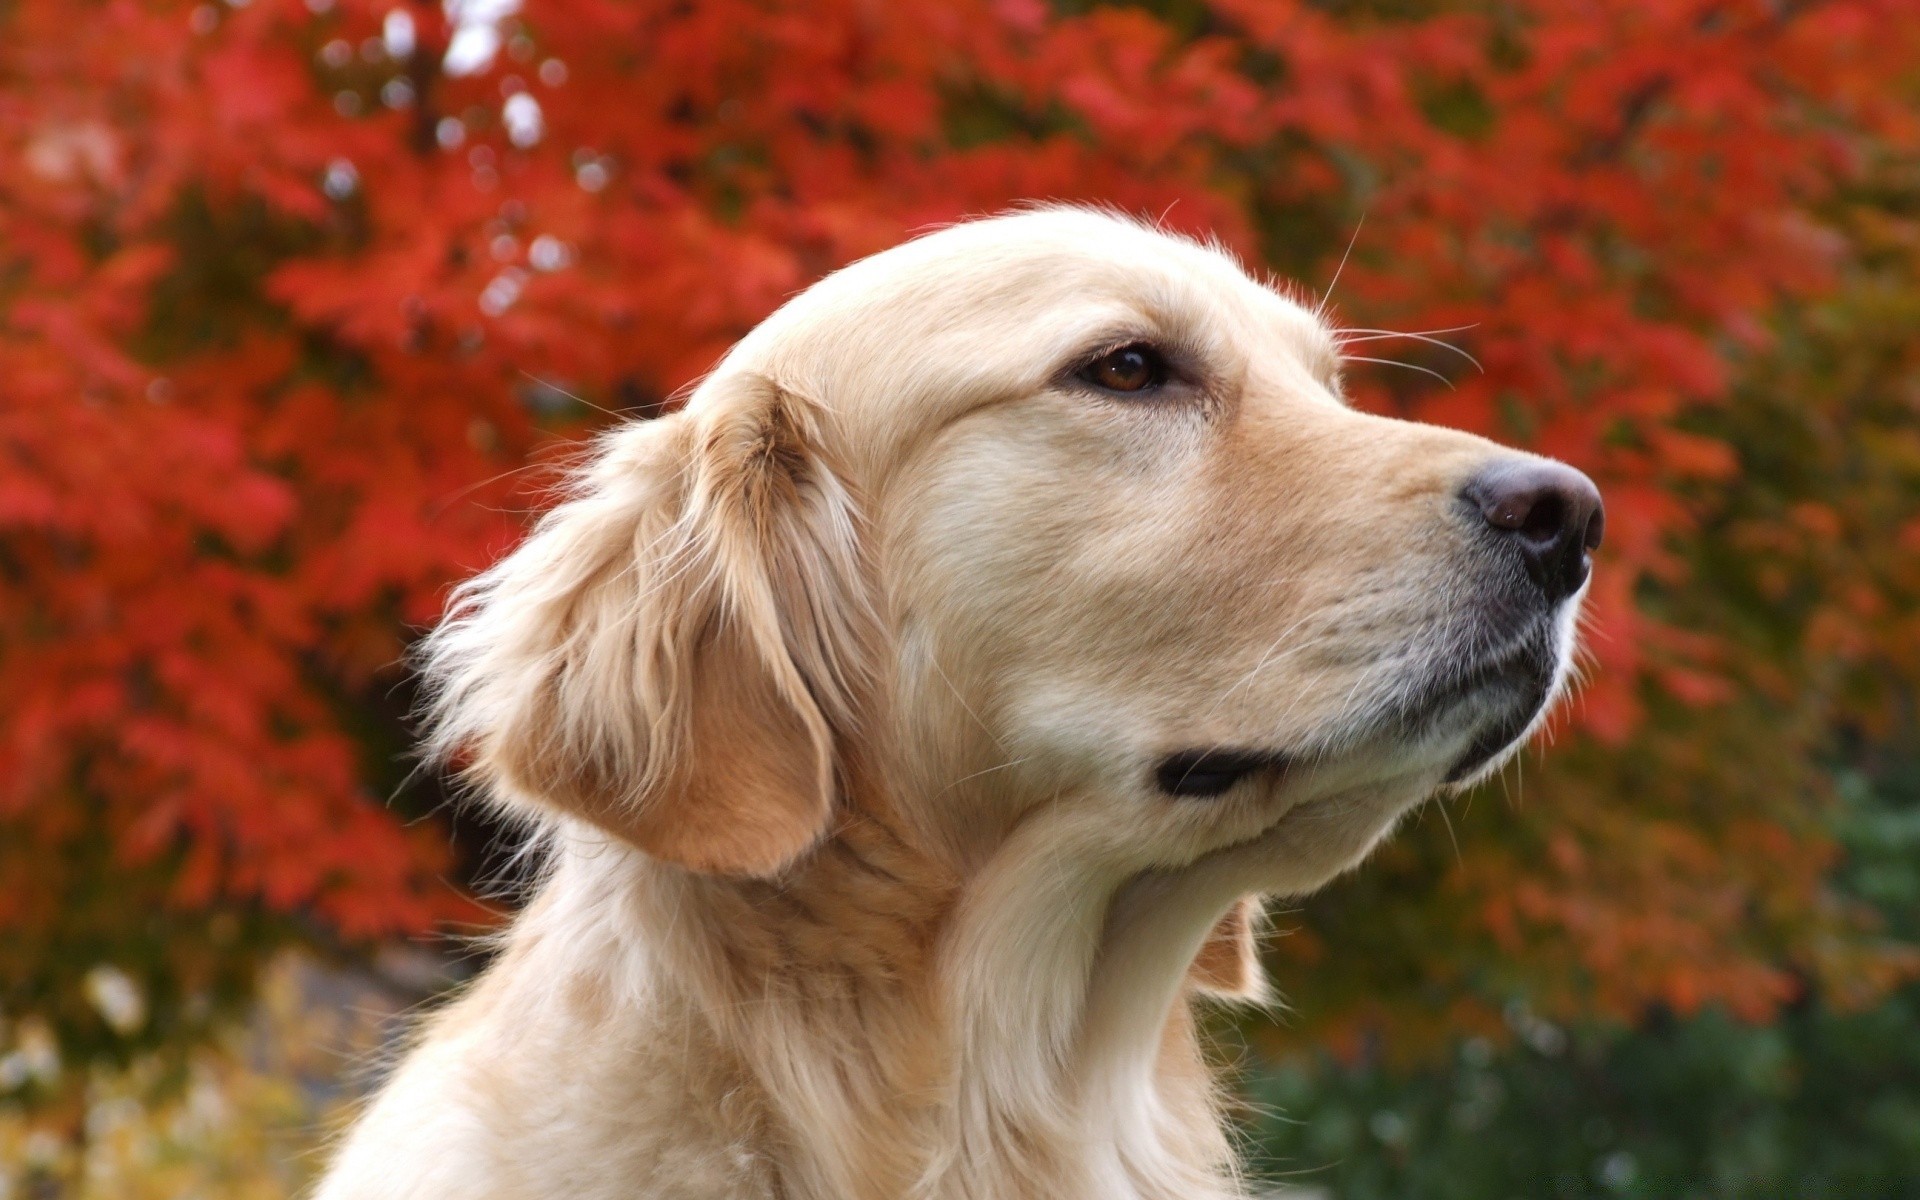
[422,372,872,876]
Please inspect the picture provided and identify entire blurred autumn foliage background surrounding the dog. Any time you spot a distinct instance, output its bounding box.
[0,0,1920,1200]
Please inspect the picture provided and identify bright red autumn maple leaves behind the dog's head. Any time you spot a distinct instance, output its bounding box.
[0,0,1920,1044]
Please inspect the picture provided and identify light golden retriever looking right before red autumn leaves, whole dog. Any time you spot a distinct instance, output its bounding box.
[319,209,1601,1200]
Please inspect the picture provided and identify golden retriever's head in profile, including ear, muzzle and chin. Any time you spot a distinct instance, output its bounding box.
[426,209,1601,975]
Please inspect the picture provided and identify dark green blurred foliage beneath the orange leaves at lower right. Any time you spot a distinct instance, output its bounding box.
[1248,737,1920,1200]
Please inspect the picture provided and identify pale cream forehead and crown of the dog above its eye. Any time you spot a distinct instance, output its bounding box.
[722,207,1338,456]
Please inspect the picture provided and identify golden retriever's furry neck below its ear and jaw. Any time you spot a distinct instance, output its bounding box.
[541,787,1233,1200]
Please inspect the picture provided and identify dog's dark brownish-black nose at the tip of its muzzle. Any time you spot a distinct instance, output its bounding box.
[1461,459,1607,605]
